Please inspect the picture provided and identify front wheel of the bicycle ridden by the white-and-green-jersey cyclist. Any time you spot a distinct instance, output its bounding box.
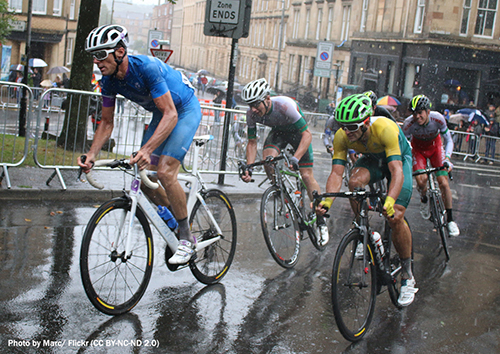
[260,186,300,268]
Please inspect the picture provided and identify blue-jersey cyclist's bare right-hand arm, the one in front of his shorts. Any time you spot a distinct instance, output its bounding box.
[130,91,178,170]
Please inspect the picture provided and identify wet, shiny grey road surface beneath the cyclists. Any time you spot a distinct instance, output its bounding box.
[0,169,500,353]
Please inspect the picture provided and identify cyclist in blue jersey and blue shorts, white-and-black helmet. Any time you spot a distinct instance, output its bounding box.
[78,25,201,264]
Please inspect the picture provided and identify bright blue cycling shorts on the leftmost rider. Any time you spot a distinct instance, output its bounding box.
[141,95,201,165]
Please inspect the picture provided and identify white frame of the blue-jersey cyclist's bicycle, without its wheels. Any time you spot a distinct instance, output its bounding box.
[87,135,222,259]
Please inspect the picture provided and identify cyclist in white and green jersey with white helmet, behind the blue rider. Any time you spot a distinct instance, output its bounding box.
[241,78,329,245]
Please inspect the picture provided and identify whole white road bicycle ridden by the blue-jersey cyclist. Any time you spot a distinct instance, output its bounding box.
[80,136,237,315]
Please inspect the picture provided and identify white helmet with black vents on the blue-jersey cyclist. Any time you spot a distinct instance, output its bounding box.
[85,25,128,52]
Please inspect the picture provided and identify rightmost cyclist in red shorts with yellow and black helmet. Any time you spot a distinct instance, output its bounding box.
[403,95,460,236]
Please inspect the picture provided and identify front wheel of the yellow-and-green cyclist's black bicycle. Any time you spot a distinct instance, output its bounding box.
[332,229,377,342]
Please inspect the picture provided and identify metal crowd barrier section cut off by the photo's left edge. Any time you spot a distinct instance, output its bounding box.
[0,81,33,189]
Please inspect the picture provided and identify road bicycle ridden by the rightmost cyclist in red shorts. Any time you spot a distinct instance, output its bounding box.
[413,166,452,261]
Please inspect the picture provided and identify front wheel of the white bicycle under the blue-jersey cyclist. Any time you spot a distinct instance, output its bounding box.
[80,198,154,315]
